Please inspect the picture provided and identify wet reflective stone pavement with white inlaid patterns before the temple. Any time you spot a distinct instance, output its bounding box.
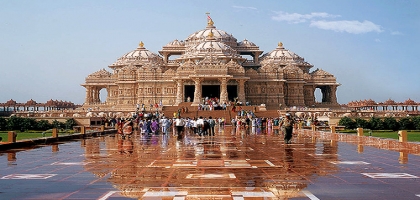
[0,127,420,200]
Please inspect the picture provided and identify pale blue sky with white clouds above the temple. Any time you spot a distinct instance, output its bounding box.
[0,0,420,104]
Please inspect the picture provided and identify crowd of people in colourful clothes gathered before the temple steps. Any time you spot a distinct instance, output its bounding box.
[108,99,322,144]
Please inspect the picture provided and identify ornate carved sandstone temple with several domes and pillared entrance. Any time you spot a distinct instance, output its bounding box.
[82,18,340,110]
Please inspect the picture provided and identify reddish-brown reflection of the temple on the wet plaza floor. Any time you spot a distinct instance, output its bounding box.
[84,130,338,199]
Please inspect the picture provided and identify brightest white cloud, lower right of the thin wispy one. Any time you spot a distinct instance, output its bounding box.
[310,20,383,34]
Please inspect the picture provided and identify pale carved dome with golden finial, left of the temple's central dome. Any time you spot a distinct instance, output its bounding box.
[112,42,163,65]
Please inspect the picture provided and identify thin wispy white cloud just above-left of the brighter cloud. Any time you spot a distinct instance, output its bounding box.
[271,12,339,24]
